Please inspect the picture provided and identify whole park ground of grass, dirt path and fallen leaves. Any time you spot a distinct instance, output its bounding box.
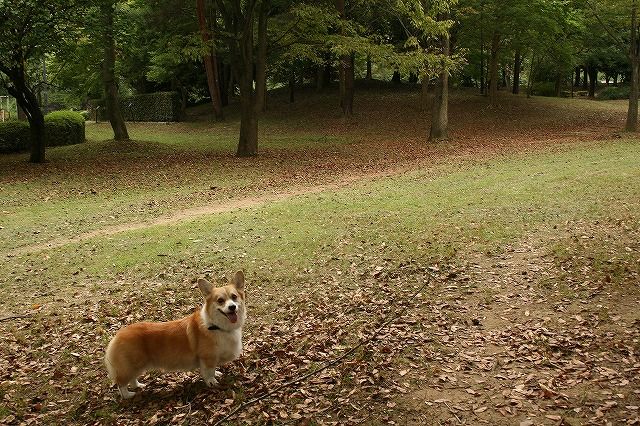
[0,87,640,425]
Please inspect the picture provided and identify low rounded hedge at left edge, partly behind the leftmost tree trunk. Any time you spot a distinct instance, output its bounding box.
[0,111,85,153]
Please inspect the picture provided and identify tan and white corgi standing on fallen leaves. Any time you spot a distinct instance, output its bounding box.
[105,271,247,399]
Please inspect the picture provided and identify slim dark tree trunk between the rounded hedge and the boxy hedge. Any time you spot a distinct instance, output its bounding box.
[102,0,129,141]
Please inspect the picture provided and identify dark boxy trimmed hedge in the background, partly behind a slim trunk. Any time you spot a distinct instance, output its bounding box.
[89,92,181,122]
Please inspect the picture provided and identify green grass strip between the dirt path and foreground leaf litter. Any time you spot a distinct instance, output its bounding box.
[0,140,640,310]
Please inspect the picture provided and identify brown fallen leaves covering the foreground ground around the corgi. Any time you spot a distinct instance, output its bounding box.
[0,220,640,426]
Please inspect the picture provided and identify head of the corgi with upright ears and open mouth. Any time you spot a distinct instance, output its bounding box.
[198,271,247,330]
